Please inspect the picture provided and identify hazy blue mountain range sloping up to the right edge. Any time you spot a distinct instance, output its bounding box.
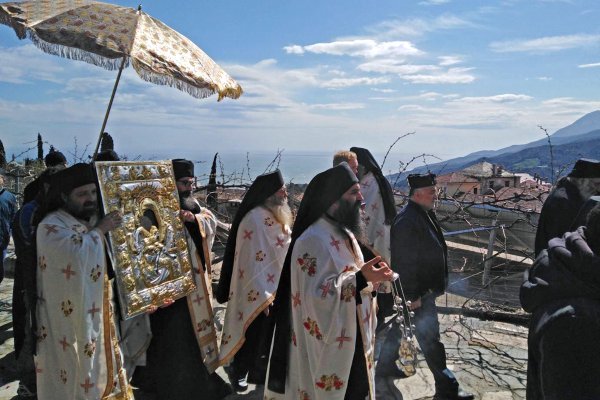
[388,111,600,187]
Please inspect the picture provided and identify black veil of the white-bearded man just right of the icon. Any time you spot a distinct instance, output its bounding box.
[215,170,285,304]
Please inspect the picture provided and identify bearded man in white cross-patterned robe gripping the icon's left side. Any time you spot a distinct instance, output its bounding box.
[35,163,133,399]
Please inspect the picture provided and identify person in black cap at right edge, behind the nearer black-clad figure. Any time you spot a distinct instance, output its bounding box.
[535,159,600,257]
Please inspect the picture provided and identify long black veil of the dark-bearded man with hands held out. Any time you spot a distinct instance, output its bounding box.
[267,162,358,393]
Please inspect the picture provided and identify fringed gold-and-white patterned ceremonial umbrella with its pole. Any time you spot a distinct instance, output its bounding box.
[0,0,242,156]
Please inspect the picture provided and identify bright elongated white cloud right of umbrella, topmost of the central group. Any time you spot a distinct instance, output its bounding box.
[284,39,422,58]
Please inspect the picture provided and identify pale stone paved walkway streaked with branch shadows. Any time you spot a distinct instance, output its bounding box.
[0,260,527,400]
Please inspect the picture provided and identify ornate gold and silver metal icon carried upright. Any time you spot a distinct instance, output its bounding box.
[96,161,195,319]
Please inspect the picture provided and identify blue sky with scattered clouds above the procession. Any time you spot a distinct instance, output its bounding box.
[0,0,600,178]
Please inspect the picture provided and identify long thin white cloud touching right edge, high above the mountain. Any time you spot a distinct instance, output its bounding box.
[490,34,600,53]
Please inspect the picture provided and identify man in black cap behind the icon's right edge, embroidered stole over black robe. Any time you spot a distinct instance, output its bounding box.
[134,159,231,400]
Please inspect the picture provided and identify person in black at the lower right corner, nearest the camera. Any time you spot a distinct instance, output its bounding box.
[520,203,600,400]
